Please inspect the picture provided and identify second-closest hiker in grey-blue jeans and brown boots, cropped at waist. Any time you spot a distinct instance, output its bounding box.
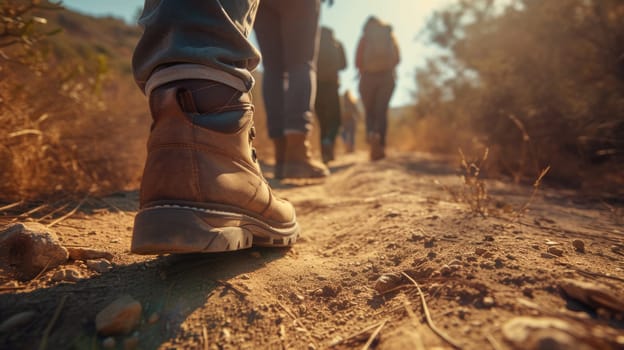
[255,0,329,178]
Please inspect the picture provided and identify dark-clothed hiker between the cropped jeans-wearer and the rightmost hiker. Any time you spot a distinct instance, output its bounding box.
[315,27,347,164]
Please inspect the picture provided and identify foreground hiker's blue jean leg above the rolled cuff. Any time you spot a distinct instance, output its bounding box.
[132,0,260,90]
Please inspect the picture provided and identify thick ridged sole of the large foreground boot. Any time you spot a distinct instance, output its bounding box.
[130,205,299,255]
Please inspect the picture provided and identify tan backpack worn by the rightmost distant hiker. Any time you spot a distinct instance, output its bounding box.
[362,26,399,73]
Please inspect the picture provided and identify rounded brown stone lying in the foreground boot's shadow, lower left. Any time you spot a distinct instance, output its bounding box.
[95,295,142,335]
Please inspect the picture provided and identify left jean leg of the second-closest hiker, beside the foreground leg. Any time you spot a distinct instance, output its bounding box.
[255,5,285,139]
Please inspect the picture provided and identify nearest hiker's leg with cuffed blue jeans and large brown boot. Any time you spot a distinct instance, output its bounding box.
[131,0,300,254]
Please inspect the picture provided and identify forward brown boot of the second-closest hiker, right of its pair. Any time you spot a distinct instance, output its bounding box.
[284,133,329,179]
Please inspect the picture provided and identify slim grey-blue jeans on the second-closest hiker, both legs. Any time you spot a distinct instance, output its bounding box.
[256,0,320,138]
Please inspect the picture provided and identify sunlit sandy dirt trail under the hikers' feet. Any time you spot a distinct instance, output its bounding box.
[0,154,624,349]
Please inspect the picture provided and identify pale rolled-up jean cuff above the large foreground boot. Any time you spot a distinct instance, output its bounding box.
[144,63,254,96]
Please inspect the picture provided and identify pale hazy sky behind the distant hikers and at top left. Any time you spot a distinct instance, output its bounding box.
[63,0,453,106]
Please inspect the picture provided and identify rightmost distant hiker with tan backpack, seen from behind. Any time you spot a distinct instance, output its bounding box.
[355,16,400,160]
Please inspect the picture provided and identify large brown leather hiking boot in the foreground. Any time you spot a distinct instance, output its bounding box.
[131,80,299,254]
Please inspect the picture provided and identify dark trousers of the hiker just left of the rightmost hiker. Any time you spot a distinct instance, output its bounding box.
[316,82,340,144]
